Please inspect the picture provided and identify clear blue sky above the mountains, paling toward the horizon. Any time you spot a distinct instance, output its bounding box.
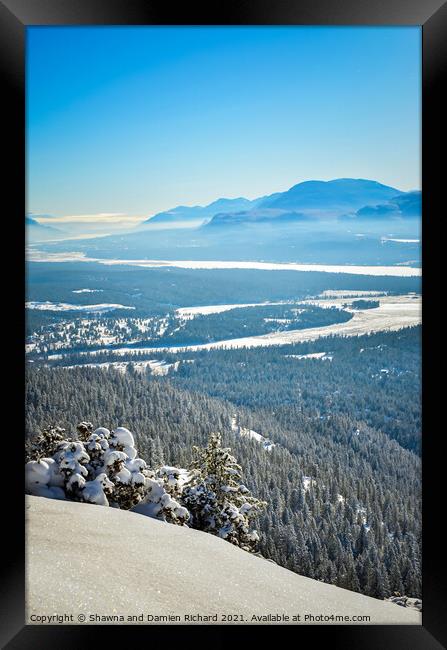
[27,27,421,220]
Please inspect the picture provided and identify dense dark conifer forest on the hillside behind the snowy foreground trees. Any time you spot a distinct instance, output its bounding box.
[26,328,421,598]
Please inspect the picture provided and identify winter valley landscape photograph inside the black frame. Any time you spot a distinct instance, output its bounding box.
[22,24,428,624]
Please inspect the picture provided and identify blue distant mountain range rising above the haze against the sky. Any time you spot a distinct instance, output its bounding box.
[144,178,421,228]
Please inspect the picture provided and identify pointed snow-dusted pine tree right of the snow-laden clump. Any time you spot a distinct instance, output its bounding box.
[182,433,266,551]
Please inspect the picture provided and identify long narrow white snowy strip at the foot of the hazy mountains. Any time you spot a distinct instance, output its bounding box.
[27,248,422,277]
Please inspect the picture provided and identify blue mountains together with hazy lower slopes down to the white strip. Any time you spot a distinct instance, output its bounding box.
[31,179,421,264]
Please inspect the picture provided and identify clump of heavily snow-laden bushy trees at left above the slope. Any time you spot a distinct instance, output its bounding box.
[25,422,189,525]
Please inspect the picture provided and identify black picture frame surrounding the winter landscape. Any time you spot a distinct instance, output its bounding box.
[0,0,447,650]
